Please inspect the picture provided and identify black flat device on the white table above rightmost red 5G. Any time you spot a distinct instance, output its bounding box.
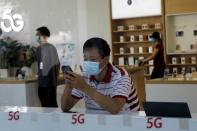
[143,101,191,118]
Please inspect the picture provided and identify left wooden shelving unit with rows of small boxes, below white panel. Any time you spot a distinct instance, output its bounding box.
[111,12,164,78]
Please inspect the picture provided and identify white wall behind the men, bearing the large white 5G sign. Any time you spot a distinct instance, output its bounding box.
[0,0,110,63]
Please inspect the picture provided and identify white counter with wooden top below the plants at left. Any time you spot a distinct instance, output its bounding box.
[0,78,40,106]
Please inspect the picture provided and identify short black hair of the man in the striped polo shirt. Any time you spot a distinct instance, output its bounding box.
[83,37,110,58]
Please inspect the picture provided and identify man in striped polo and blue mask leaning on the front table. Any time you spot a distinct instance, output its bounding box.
[61,37,139,114]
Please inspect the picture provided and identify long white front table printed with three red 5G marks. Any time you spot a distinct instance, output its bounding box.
[0,107,197,131]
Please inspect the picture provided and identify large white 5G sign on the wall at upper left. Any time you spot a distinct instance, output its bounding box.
[0,9,25,32]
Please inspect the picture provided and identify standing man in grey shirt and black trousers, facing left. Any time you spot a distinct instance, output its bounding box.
[35,26,60,107]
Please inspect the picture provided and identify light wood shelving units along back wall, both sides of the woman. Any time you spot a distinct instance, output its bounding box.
[111,0,197,78]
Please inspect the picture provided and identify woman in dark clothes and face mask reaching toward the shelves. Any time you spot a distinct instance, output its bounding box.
[142,32,166,79]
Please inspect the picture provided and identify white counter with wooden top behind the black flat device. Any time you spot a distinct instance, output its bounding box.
[146,77,197,113]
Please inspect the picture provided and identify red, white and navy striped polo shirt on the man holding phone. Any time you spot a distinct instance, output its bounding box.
[72,64,140,113]
